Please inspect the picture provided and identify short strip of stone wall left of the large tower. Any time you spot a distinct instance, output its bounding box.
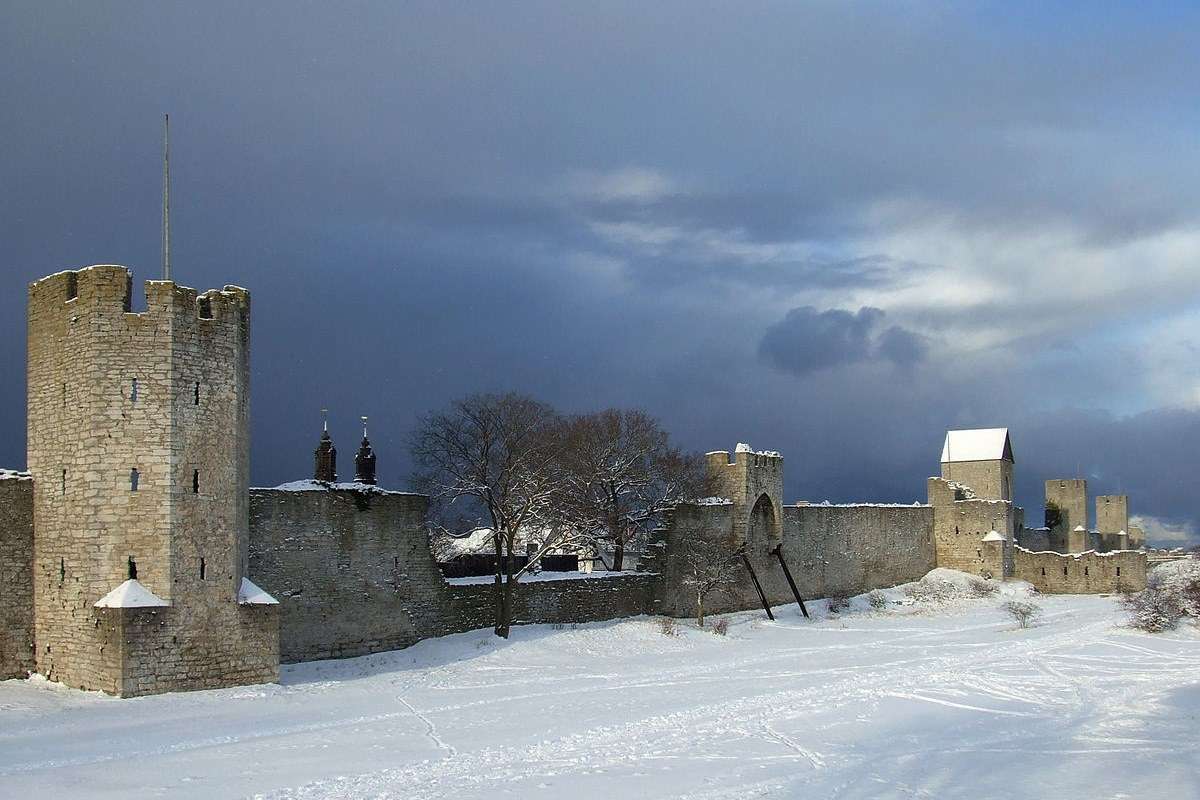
[0,470,35,680]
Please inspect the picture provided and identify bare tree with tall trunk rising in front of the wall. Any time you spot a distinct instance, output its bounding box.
[410,393,570,638]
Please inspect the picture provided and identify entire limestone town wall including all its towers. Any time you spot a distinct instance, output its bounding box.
[0,266,1146,696]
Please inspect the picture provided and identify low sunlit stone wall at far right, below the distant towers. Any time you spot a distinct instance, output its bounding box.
[1013,547,1146,595]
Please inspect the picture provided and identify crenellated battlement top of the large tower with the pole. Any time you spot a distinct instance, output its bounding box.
[29,264,250,324]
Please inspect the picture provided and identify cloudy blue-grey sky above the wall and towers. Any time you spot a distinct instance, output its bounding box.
[0,2,1200,542]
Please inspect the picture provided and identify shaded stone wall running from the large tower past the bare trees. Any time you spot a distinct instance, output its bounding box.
[250,487,656,663]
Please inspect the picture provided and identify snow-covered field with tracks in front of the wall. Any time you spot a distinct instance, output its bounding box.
[0,568,1200,800]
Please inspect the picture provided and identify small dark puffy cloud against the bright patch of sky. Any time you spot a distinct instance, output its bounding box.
[758,306,925,375]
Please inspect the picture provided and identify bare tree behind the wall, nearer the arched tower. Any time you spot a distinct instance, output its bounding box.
[562,409,704,570]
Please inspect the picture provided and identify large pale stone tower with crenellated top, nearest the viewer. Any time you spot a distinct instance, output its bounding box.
[28,266,278,696]
